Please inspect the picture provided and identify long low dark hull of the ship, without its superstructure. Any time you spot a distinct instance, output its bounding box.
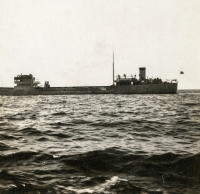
[0,83,178,96]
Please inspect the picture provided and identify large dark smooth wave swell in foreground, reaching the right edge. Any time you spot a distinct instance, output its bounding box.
[60,149,200,182]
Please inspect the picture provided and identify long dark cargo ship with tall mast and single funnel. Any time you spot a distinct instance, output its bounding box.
[0,67,178,96]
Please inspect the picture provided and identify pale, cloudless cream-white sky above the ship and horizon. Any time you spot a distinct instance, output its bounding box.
[0,0,200,89]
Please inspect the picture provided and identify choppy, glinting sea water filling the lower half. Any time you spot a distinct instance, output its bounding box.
[0,93,200,194]
